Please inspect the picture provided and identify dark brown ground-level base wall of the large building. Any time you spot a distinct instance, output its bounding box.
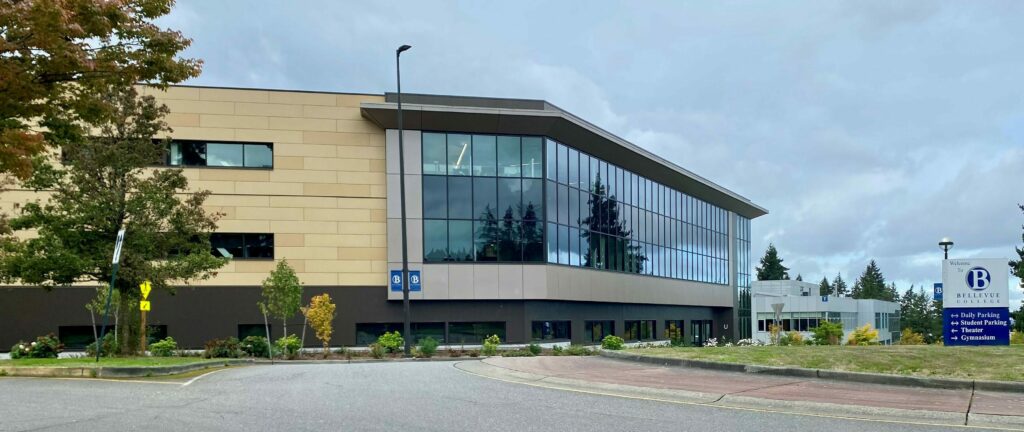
[0,287,735,352]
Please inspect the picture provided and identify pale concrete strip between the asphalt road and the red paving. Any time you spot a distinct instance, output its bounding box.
[455,361,991,427]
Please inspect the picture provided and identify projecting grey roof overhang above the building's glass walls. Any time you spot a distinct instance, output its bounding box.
[360,93,768,219]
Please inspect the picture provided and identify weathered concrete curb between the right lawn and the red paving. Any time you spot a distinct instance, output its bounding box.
[599,350,1024,393]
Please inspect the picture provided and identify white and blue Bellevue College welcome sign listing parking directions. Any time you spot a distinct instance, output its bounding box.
[936,259,1010,345]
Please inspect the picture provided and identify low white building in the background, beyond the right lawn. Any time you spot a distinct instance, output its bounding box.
[751,280,900,345]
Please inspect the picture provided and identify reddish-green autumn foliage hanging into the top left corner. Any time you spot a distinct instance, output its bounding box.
[0,0,202,180]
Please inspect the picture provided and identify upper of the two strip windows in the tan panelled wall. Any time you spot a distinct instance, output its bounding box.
[167,140,273,169]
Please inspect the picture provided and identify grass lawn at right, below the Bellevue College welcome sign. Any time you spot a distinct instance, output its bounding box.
[626,345,1024,381]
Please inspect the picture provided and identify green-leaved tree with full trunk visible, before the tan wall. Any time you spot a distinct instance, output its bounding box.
[0,86,225,353]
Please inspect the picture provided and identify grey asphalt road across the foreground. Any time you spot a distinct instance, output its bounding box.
[0,361,991,432]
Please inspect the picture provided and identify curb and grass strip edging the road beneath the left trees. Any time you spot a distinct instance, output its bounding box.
[0,358,253,378]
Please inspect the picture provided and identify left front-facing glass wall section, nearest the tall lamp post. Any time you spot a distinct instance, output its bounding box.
[422,132,544,262]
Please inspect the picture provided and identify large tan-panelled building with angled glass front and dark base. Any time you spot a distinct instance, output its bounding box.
[0,86,767,347]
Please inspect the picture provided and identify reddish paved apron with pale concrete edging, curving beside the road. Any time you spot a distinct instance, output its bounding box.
[457,357,1024,430]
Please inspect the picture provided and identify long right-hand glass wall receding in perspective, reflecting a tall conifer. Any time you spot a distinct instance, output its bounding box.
[545,139,729,285]
